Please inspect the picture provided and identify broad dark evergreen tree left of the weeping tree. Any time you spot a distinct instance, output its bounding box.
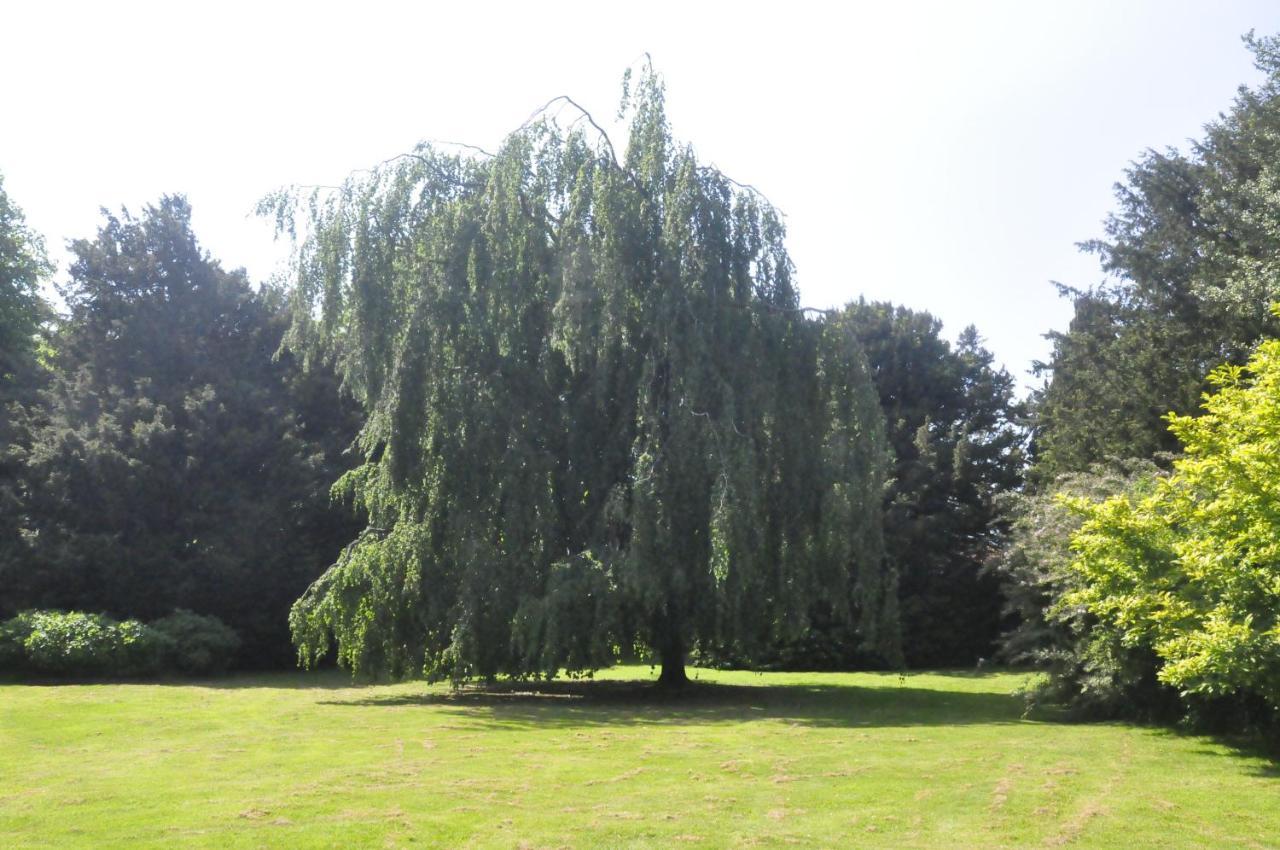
[0,197,355,663]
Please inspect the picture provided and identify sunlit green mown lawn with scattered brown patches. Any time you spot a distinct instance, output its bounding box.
[0,667,1280,849]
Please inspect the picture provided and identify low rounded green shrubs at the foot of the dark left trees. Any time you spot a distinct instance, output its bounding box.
[0,611,239,678]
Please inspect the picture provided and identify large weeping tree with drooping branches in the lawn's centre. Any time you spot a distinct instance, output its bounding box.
[262,72,897,684]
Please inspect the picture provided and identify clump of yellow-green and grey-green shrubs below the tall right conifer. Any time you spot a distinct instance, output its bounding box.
[997,341,1280,744]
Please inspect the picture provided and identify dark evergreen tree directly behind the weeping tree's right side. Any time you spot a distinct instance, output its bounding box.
[842,301,1024,667]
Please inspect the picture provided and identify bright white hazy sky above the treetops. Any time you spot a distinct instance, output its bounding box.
[0,0,1280,384]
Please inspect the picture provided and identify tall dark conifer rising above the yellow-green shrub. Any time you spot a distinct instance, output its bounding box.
[1034,38,1280,481]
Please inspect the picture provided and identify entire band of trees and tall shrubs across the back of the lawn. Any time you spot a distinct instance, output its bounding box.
[0,37,1280,727]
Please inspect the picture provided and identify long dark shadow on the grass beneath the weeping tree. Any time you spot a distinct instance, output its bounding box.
[321,681,1023,730]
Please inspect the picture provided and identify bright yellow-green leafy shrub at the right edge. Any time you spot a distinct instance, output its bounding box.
[1064,341,1280,708]
